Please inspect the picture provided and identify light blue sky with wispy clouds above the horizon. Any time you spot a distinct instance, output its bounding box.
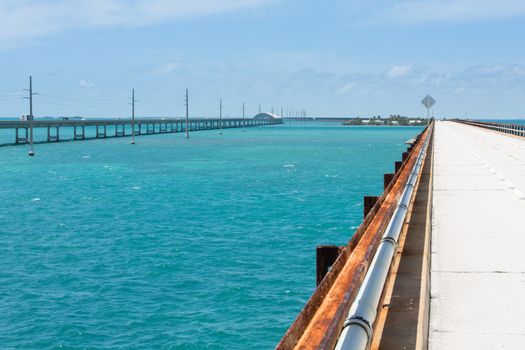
[0,0,525,118]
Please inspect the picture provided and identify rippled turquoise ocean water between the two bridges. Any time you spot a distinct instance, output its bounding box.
[0,123,421,349]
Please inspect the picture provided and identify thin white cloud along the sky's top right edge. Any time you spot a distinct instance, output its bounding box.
[377,0,525,23]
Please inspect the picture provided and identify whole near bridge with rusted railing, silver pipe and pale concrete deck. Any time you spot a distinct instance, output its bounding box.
[277,120,525,350]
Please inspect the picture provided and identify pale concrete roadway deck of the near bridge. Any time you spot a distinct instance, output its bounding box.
[429,122,525,349]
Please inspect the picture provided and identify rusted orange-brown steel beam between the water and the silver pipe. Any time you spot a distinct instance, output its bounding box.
[276,124,428,350]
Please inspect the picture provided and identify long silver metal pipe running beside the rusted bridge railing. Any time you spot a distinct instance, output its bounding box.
[335,130,430,350]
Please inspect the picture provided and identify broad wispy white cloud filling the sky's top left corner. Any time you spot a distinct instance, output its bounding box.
[0,0,274,47]
